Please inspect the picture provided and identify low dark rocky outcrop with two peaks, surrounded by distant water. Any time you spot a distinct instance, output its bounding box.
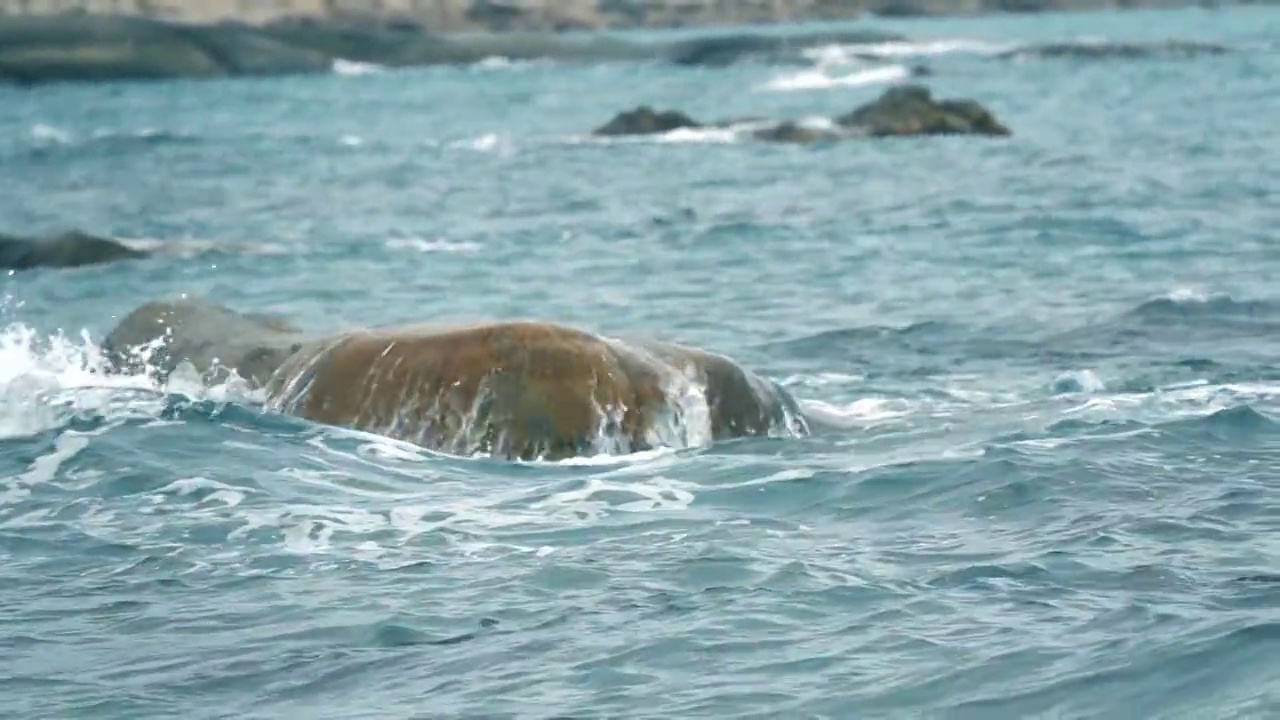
[593,85,1010,143]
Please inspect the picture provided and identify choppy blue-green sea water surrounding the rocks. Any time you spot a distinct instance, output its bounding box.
[0,8,1280,719]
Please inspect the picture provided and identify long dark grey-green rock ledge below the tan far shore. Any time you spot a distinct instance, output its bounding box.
[0,15,902,85]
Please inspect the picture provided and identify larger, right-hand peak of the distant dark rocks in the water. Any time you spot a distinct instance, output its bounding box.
[836,85,1010,137]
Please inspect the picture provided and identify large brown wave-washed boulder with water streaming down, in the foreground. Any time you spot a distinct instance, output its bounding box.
[104,299,808,460]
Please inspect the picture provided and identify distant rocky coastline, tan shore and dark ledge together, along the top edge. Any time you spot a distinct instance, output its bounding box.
[0,0,1239,86]
